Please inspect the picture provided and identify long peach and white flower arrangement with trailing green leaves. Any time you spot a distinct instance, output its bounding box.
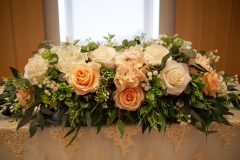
[0,34,240,144]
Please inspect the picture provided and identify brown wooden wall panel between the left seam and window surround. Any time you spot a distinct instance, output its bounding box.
[11,0,44,72]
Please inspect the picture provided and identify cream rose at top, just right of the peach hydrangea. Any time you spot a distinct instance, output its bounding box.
[144,44,169,65]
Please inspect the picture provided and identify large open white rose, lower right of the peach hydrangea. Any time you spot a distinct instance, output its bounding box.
[160,60,192,95]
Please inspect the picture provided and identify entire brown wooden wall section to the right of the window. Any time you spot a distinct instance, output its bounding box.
[175,0,240,75]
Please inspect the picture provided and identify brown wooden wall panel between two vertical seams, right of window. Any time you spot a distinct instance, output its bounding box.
[201,0,233,71]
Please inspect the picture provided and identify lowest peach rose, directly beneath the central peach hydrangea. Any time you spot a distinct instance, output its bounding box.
[113,86,144,111]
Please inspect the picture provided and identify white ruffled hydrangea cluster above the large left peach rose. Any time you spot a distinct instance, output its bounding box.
[51,45,88,75]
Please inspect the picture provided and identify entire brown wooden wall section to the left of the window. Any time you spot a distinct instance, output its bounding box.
[0,0,45,77]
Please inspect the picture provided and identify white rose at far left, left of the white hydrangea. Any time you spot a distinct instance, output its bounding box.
[24,54,48,83]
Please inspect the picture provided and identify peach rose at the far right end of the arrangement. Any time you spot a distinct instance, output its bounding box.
[203,70,221,97]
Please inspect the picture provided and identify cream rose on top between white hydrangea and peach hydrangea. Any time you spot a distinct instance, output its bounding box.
[88,46,117,69]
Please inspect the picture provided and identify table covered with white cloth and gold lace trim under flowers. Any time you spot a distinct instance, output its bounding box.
[0,87,240,160]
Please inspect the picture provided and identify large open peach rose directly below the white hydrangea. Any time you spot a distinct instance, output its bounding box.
[66,63,100,95]
